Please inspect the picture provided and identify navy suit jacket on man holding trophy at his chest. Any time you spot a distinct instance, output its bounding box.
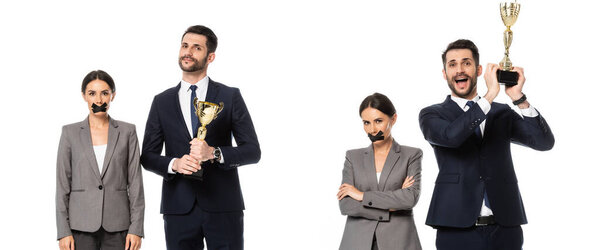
[141,80,260,214]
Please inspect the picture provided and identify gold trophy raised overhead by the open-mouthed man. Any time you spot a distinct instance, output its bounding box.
[497,0,521,87]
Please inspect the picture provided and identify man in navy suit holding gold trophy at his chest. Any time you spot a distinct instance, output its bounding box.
[141,25,260,250]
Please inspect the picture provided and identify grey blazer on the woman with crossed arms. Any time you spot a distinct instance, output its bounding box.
[339,141,423,250]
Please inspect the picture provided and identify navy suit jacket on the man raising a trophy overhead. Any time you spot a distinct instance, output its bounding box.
[419,96,554,228]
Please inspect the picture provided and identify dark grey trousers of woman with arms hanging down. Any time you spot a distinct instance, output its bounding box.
[72,227,127,250]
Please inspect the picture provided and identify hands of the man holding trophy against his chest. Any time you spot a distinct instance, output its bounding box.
[173,138,215,175]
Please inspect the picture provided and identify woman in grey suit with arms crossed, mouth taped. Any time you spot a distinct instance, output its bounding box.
[337,93,423,250]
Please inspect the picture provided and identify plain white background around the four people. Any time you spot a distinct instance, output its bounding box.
[0,0,600,250]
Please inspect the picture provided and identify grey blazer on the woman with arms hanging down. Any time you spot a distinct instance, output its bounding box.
[56,117,144,239]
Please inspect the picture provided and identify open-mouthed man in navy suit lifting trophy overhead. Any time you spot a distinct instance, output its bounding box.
[419,39,554,250]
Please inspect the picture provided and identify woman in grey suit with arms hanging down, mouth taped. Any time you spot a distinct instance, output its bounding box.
[56,70,144,250]
